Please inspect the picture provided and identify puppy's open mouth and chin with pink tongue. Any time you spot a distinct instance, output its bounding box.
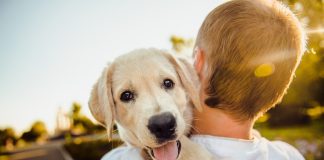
[147,140,181,160]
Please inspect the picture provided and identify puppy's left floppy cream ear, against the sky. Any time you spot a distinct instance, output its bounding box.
[89,65,115,139]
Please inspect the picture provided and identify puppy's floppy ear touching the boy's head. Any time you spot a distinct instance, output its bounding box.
[164,53,202,111]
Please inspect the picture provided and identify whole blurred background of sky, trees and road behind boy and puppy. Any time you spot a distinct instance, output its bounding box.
[0,0,324,160]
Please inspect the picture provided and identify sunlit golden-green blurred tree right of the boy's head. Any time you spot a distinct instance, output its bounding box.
[283,0,324,106]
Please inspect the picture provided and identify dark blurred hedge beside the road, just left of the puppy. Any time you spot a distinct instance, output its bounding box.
[64,139,123,160]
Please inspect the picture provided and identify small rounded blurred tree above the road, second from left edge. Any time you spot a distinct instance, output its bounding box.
[21,121,48,142]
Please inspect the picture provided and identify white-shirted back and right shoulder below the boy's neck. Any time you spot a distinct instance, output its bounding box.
[191,135,304,160]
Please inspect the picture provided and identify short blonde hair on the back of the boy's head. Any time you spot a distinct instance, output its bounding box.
[196,0,305,120]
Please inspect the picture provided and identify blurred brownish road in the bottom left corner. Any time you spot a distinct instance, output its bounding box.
[9,141,72,160]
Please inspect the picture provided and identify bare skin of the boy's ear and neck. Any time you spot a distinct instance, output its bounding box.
[193,47,254,140]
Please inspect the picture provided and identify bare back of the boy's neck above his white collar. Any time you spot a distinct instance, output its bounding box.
[193,106,254,140]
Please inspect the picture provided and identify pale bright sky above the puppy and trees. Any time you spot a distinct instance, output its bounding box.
[0,0,222,133]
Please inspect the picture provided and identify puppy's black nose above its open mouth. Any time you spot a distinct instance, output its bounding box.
[147,112,176,142]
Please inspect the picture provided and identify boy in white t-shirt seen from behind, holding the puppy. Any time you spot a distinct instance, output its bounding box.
[103,0,305,160]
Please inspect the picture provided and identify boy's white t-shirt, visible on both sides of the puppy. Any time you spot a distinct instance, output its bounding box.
[102,135,304,160]
